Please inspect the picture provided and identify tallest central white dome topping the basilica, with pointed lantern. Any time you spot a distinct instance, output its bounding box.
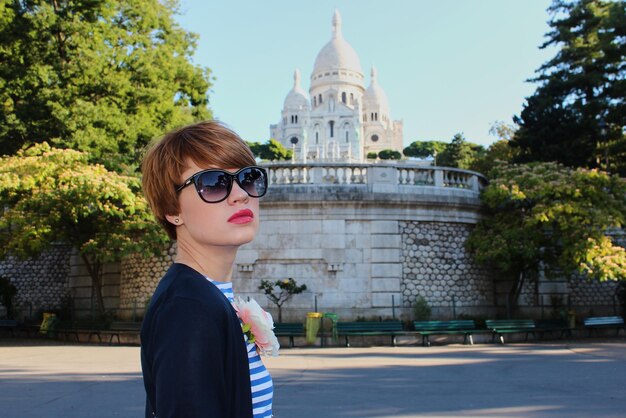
[313,10,363,74]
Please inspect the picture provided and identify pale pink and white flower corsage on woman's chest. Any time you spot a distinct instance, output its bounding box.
[233,297,280,357]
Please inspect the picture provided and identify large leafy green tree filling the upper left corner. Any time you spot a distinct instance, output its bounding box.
[0,0,211,168]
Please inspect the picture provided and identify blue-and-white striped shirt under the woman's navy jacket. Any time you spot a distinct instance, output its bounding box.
[207,277,274,418]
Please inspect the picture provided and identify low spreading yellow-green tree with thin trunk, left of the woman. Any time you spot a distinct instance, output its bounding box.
[0,143,167,315]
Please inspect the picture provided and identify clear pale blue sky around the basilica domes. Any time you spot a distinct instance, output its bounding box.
[173,0,555,145]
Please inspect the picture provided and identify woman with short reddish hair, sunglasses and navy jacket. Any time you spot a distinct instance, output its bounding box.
[141,121,273,418]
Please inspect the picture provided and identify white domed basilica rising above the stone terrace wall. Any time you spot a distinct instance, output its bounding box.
[270,11,403,162]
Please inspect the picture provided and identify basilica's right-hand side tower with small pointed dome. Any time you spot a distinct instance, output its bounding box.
[362,66,402,155]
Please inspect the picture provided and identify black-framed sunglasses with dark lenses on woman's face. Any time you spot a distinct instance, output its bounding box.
[176,166,267,203]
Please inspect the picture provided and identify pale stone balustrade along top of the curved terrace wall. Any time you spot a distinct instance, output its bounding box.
[264,162,487,194]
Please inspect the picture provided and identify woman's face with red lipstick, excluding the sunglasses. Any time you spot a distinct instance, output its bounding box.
[172,160,259,247]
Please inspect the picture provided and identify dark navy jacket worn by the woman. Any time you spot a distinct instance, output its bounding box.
[141,263,252,418]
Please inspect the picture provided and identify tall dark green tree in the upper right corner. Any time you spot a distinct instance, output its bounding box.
[513,0,626,175]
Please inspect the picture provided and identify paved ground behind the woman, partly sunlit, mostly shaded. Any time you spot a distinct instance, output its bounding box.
[0,338,626,418]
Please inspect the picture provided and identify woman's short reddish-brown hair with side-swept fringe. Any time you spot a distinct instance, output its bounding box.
[141,120,256,240]
